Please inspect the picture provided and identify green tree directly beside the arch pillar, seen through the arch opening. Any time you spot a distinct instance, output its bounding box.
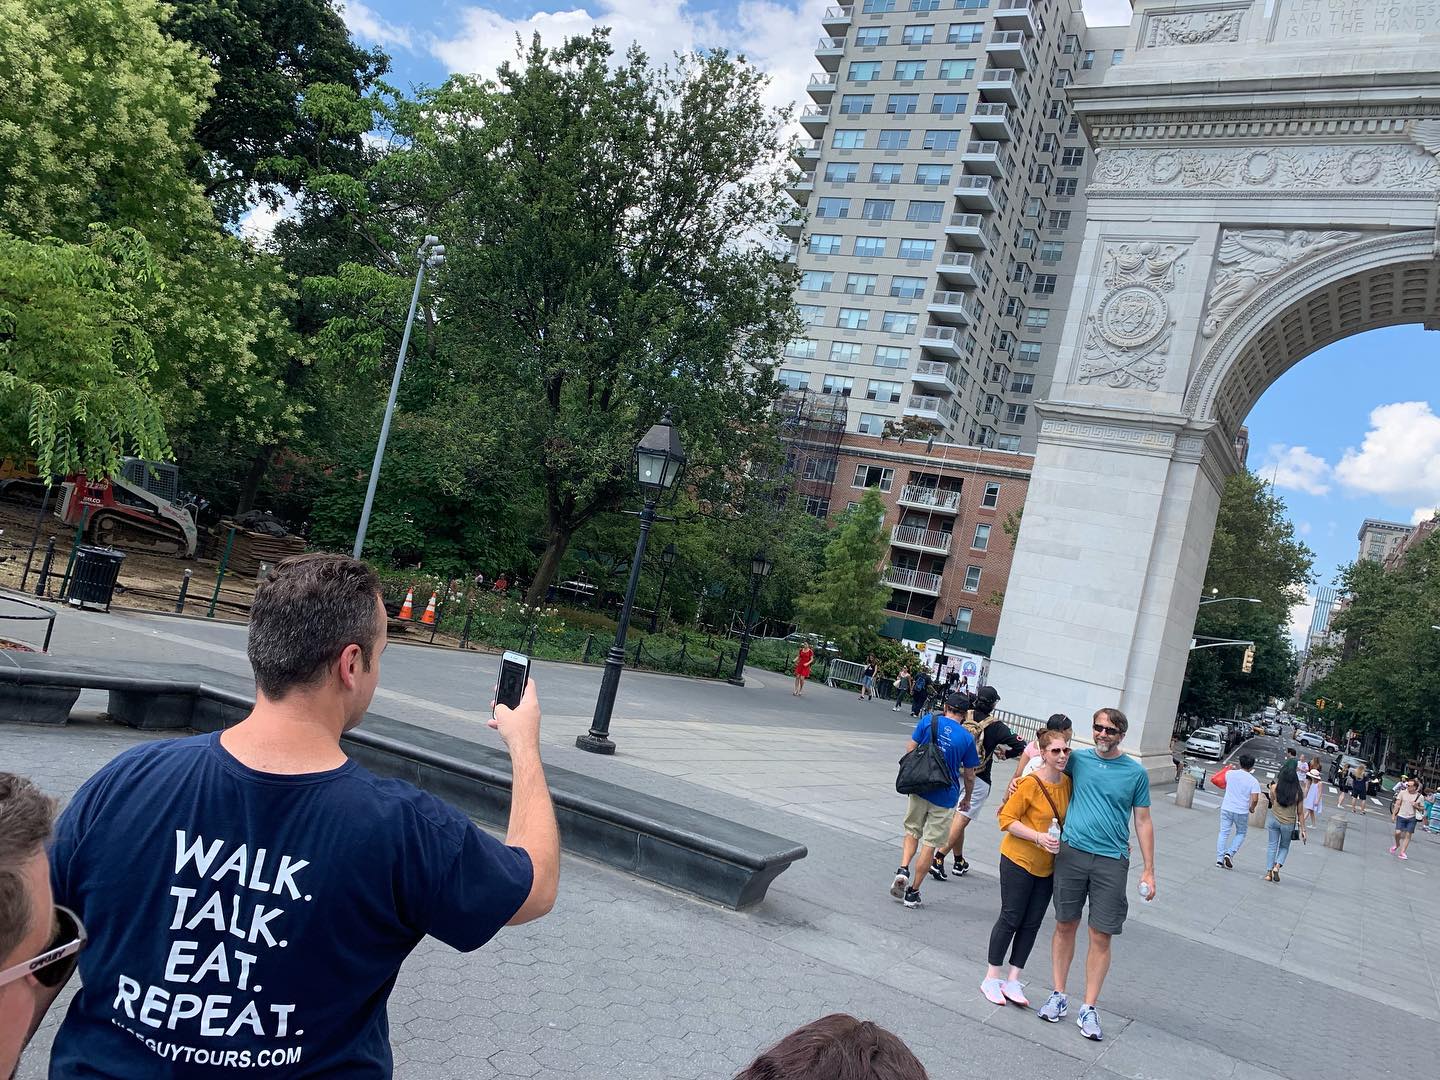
[1179,472,1315,717]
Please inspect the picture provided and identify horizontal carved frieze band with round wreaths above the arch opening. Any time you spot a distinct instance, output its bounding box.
[1087,143,1440,197]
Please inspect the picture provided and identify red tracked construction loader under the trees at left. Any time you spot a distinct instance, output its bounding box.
[55,458,200,559]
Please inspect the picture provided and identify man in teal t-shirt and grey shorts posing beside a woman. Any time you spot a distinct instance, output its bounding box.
[1040,708,1155,1043]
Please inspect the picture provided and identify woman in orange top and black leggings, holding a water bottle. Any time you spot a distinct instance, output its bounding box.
[981,729,1070,1005]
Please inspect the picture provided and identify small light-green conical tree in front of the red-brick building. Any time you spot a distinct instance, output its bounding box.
[799,488,888,657]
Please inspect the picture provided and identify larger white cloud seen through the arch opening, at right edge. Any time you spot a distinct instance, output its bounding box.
[1335,402,1440,505]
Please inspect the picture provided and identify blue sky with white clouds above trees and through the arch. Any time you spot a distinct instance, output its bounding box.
[331,0,1440,642]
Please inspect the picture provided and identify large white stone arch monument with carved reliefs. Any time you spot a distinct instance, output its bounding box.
[991,0,1440,772]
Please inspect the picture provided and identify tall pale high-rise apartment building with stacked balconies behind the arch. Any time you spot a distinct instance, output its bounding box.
[779,0,1128,451]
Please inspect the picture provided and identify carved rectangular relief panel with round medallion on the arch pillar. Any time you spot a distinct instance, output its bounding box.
[1077,240,1185,390]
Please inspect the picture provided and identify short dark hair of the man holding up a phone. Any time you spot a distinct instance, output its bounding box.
[245,553,380,700]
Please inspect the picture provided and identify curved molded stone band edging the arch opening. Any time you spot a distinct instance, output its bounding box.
[1181,229,1437,420]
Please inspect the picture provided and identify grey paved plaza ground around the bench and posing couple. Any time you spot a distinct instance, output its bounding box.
[0,612,1440,1080]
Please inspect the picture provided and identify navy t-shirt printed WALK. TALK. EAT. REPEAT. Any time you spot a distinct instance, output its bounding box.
[50,734,533,1080]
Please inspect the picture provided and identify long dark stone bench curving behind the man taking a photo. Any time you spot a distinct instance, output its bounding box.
[0,654,806,910]
